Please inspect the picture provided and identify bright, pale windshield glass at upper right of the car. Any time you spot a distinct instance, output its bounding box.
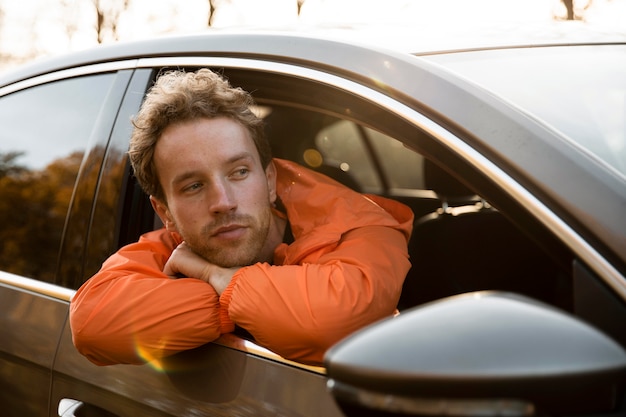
[428,45,626,178]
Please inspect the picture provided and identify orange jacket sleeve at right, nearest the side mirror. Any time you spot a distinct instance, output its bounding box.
[221,226,410,364]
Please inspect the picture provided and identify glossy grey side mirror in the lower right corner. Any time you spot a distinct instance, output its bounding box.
[325,292,626,417]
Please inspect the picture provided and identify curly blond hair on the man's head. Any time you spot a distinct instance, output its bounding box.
[128,68,272,201]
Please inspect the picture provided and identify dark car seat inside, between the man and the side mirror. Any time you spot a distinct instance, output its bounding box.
[398,160,559,310]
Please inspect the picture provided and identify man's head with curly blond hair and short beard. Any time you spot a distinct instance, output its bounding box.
[129,70,282,267]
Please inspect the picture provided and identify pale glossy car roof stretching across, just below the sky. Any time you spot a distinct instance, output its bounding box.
[0,22,626,87]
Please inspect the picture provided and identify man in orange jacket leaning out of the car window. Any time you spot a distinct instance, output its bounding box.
[70,69,413,365]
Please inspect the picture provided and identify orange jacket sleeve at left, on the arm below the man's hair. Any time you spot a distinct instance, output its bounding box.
[70,229,224,365]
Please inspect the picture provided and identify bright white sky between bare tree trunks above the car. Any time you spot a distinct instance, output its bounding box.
[0,0,626,70]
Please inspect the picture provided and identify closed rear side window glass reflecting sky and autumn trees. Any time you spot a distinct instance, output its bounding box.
[0,74,114,282]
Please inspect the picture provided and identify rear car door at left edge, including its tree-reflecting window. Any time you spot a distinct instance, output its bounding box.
[0,66,128,416]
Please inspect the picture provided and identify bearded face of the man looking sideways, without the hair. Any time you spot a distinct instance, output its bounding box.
[152,117,276,267]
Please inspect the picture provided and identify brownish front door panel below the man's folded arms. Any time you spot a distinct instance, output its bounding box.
[51,316,341,416]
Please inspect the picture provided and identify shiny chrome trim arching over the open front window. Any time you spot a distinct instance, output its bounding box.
[130,57,626,298]
